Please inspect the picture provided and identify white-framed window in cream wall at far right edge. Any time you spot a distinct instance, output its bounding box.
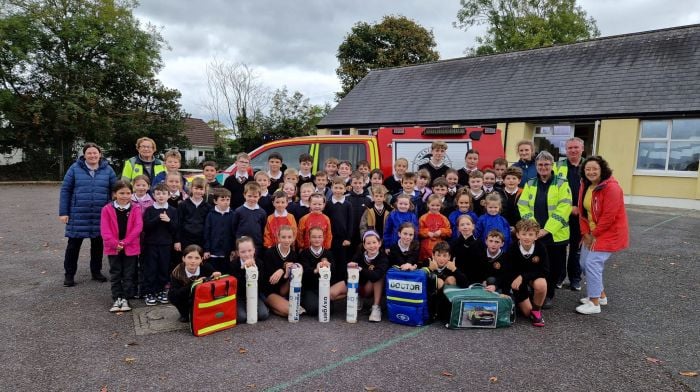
[637,118,700,172]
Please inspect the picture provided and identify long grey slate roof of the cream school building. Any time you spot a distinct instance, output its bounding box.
[318,25,700,127]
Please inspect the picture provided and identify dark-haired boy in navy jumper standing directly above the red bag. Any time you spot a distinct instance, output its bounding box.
[204,188,235,275]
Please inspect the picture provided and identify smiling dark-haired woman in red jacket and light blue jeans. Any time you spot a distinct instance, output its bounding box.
[576,156,629,314]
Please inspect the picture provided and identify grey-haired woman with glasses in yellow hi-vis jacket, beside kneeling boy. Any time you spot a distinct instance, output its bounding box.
[518,151,571,309]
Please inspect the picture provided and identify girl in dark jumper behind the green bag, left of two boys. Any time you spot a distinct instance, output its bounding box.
[450,214,484,287]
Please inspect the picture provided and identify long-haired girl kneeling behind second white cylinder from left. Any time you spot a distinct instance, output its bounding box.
[259,225,298,317]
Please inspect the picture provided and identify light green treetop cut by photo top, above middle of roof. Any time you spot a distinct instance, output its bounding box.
[454,0,600,55]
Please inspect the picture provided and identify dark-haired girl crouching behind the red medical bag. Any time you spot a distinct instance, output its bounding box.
[168,244,221,323]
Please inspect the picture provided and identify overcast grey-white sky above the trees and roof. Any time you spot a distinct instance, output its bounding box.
[135,0,700,120]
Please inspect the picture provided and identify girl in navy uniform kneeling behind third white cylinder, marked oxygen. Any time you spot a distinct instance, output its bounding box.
[299,226,347,316]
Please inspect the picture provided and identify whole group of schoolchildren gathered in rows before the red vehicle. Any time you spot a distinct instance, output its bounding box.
[102,141,548,326]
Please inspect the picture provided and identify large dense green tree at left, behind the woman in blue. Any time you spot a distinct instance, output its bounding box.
[0,0,188,175]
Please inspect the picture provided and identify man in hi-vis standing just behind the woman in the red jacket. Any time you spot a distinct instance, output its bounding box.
[557,137,583,291]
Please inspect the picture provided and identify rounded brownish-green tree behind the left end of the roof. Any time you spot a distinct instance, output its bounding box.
[335,16,440,100]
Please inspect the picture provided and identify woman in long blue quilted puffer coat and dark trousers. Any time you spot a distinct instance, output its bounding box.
[58,143,117,287]
